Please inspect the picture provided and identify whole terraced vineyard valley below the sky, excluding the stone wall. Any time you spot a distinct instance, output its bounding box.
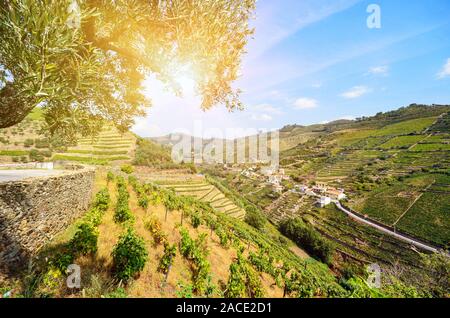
[0,105,450,297]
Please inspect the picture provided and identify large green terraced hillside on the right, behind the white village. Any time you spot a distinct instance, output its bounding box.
[208,105,450,290]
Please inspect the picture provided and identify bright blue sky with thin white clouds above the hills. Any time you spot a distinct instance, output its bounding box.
[133,0,450,136]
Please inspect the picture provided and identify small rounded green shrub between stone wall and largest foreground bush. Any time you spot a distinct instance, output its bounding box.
[69,222,98,255]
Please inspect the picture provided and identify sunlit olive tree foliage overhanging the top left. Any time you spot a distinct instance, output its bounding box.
[0,0,255,138]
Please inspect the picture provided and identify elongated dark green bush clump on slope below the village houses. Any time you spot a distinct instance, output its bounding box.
[280,218,334,264]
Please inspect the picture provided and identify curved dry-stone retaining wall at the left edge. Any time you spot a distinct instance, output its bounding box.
[0,168,95,280]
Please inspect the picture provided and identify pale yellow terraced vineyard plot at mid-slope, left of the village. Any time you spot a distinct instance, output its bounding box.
[162,181,245,219]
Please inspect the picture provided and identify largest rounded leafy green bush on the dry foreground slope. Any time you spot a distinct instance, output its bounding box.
[112,228,148,281]
